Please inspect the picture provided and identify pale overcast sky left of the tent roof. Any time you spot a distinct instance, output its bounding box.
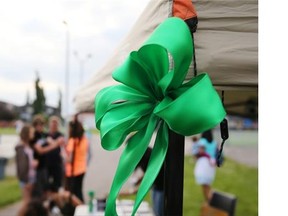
[0,0,149,115]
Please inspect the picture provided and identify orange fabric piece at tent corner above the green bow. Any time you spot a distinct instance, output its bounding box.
[173,0,197,20]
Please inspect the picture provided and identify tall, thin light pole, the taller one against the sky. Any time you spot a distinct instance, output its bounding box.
[63,20,70,134]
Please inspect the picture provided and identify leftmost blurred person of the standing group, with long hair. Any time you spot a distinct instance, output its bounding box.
[15,124,38,216]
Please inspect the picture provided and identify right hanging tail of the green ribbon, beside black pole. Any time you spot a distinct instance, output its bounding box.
[132,122,168,215]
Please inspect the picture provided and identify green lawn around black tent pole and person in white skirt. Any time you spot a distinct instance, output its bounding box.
[120,156,258,216]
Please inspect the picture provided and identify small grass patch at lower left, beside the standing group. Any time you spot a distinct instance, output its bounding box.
[0,176,21,208]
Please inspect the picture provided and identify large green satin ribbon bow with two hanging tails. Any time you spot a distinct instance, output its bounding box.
[95,17,226,216]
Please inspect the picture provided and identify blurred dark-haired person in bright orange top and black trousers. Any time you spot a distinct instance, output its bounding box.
[65,118,88,202]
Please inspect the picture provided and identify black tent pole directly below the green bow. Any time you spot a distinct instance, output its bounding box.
[164,130,185,216]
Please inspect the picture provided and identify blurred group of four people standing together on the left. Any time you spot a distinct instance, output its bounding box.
[15,115,89,216]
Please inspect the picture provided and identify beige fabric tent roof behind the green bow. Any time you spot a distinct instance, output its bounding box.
[74,0,258,116]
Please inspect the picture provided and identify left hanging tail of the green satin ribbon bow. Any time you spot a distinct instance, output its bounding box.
[105,115,159,216]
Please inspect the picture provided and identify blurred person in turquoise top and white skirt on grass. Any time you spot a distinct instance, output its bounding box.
[193,130,217,203]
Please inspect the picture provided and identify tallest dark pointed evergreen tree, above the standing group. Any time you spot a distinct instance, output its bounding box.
[33,71,46,114]
